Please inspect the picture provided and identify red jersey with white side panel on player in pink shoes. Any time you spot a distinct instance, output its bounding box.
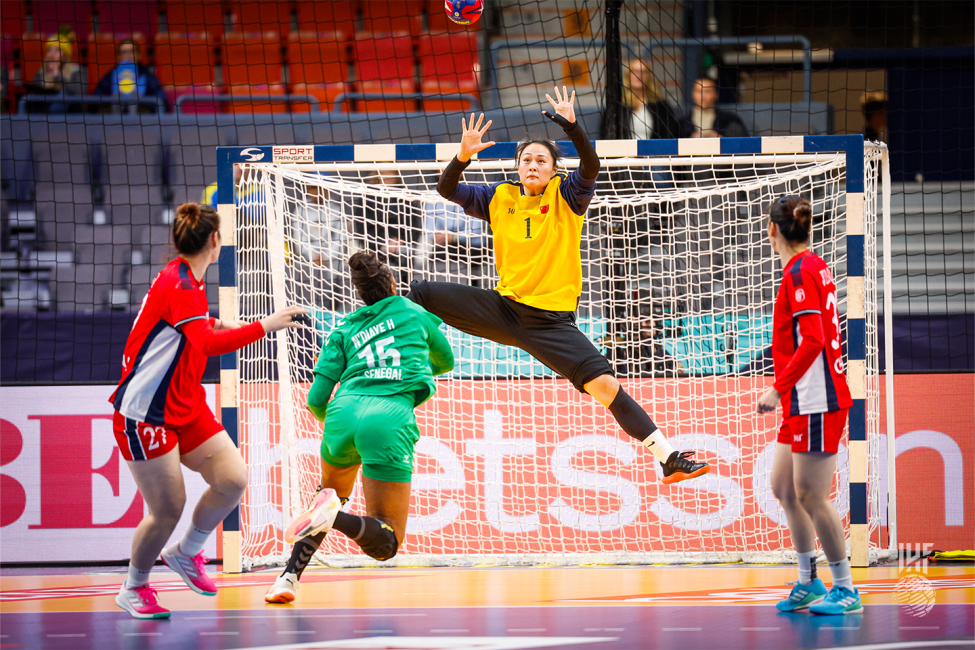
[110,258,210,426]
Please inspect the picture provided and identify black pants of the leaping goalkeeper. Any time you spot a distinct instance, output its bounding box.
[406,280,615,393]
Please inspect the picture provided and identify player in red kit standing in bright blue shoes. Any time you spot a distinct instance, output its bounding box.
[758,196,863,614]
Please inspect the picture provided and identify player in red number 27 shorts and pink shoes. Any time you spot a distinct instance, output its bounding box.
[110,203,307,618]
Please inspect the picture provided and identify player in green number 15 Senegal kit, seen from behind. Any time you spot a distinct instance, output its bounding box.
[264,252,454,603]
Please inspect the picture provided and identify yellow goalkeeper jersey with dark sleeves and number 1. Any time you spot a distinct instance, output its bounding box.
[451,170,596,311]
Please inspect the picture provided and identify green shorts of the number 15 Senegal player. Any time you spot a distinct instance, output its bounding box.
[322,395,420,483]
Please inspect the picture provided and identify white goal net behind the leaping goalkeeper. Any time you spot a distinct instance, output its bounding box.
[236,140,889,569]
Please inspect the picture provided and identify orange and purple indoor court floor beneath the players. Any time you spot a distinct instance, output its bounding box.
[0,565,975,650]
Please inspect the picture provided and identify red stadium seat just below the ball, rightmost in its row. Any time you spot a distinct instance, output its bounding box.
[419,34,480,112]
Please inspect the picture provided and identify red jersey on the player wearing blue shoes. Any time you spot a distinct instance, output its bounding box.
[772,250,853,417]
